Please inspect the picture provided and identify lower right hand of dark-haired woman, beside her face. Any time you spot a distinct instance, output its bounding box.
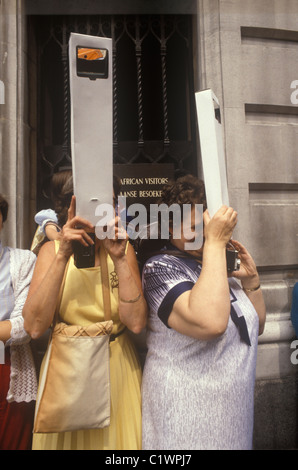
[230,240,260,289]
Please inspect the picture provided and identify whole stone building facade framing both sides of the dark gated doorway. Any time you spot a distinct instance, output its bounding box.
[0,0,298,449]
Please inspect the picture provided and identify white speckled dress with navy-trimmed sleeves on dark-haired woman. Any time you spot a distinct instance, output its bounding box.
[142,253,259,450]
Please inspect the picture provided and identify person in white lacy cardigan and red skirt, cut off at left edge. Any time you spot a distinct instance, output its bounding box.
[0,195,37,450]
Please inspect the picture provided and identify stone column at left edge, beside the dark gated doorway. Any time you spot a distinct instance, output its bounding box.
[0,0,32,248]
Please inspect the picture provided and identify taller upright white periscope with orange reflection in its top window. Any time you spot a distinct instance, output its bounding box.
[69,33,113,225]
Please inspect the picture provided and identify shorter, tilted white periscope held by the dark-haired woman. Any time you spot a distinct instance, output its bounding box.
[195,90,229,217]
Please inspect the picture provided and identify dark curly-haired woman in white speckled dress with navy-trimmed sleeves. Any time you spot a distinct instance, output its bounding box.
[142,175,266,450]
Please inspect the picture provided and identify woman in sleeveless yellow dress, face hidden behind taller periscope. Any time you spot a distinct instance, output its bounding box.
[23,185,147,450]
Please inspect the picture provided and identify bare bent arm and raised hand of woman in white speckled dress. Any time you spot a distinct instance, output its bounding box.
[168,206,237,340]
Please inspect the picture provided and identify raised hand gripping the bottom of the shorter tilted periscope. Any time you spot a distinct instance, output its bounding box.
[203,206,237,246]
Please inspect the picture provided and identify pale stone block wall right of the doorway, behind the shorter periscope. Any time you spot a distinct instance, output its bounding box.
[197,0,298,449]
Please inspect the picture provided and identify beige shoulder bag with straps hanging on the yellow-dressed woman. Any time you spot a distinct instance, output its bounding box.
[34,249,113,433]
